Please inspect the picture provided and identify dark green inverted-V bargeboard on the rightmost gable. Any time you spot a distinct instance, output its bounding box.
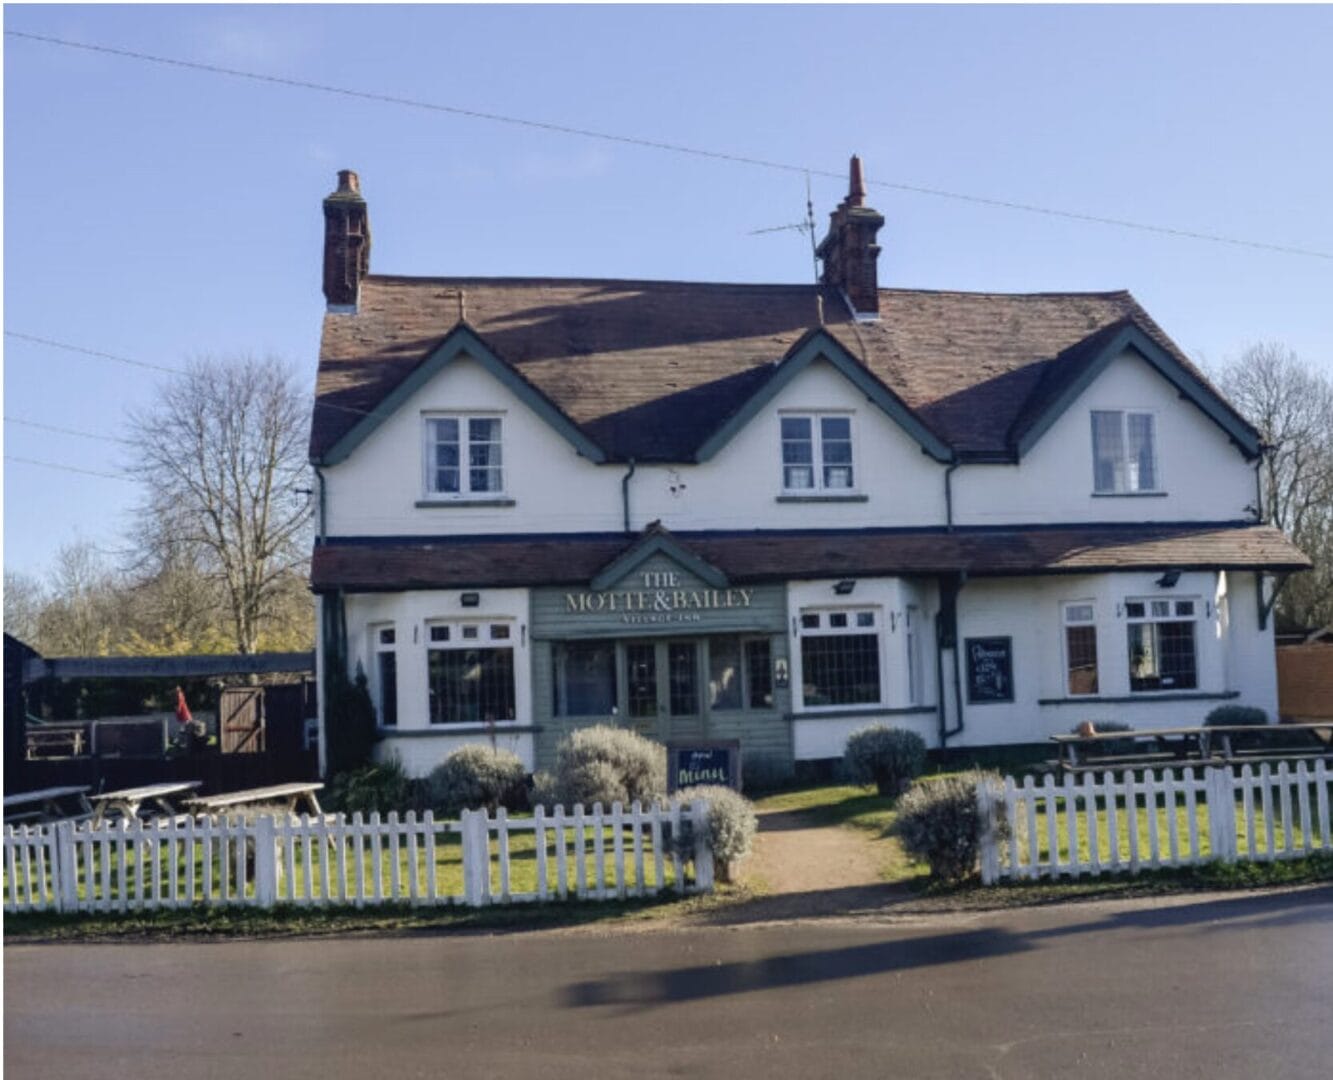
[1010,320,1261,460]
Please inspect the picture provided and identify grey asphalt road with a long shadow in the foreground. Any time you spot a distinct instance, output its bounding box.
[4,888,1333,1080]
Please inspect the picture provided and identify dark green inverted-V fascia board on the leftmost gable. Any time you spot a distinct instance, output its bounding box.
[315,323,607,465]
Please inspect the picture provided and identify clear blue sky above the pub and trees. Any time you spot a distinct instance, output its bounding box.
[4,4,1333,573]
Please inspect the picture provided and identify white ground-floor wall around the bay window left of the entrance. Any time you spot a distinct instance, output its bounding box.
[347,589,533,776]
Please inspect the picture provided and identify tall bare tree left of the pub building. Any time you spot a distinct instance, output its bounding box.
[129,357,311,653]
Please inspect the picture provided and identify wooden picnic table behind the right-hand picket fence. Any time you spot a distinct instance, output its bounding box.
[1050,723,1333,772]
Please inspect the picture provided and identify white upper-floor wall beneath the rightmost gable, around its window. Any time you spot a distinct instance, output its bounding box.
[953,353,1256,525]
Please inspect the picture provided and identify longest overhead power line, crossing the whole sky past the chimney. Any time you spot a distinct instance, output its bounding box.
[5,29,1333,261]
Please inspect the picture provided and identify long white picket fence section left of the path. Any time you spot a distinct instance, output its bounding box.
[4,801,713,912]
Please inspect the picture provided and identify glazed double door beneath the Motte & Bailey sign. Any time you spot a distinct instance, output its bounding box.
[625,639,704,741]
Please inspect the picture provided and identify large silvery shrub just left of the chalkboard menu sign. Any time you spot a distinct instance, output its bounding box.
[540,725,667,807]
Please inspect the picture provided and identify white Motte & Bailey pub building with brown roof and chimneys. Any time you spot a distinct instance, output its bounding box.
[311,159,1309,775]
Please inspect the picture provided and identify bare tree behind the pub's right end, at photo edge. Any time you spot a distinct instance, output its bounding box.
[1218,341,1333,627]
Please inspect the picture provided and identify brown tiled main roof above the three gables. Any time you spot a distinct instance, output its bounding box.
[311,275,1237,461]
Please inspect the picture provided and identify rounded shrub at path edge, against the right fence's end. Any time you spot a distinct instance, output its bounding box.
[892,771,1002,881]
